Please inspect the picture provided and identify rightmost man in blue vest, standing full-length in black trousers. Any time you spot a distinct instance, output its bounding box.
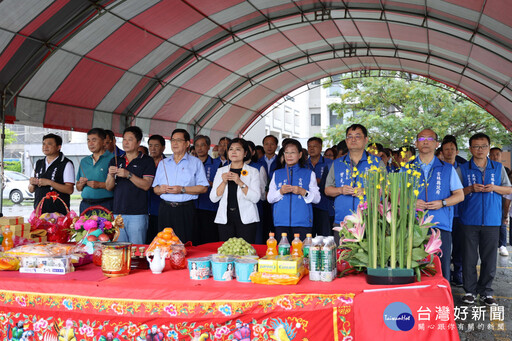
[459,133,512,306]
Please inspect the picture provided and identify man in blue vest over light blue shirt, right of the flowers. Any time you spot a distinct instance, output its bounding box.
[409,129,464,281]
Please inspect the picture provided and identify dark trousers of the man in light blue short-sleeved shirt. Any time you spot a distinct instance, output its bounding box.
[158,200,199,245]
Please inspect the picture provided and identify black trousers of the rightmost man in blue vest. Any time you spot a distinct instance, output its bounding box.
[462,225,500,296]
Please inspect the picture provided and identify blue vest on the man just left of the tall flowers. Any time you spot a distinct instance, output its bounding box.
[332,151,380,224]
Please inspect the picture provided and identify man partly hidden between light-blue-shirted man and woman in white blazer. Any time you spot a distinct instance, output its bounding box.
[194,135,221,244]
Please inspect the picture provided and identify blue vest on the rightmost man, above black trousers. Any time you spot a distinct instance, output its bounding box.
[459,158,503,226]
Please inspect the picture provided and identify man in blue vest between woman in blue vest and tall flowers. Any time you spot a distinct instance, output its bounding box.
[325,124,386,240]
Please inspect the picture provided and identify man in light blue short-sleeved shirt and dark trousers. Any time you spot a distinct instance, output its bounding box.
[153,129,209,244]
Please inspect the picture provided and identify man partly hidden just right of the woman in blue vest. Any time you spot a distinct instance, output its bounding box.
[307,137,334,236]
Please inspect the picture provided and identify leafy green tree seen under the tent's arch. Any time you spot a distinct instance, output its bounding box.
[324,72,511,149]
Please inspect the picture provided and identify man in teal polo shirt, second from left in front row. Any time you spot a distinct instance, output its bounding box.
[76,128,114,214]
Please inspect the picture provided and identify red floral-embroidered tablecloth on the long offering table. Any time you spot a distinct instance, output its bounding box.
[0,244,458,341]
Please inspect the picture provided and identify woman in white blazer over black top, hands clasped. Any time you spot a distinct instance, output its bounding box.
[210,138,261,244]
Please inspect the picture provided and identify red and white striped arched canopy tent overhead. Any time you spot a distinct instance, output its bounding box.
[0,0,512,140]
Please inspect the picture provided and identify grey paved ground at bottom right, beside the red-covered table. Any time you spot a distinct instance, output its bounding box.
[452,246,512,341]
